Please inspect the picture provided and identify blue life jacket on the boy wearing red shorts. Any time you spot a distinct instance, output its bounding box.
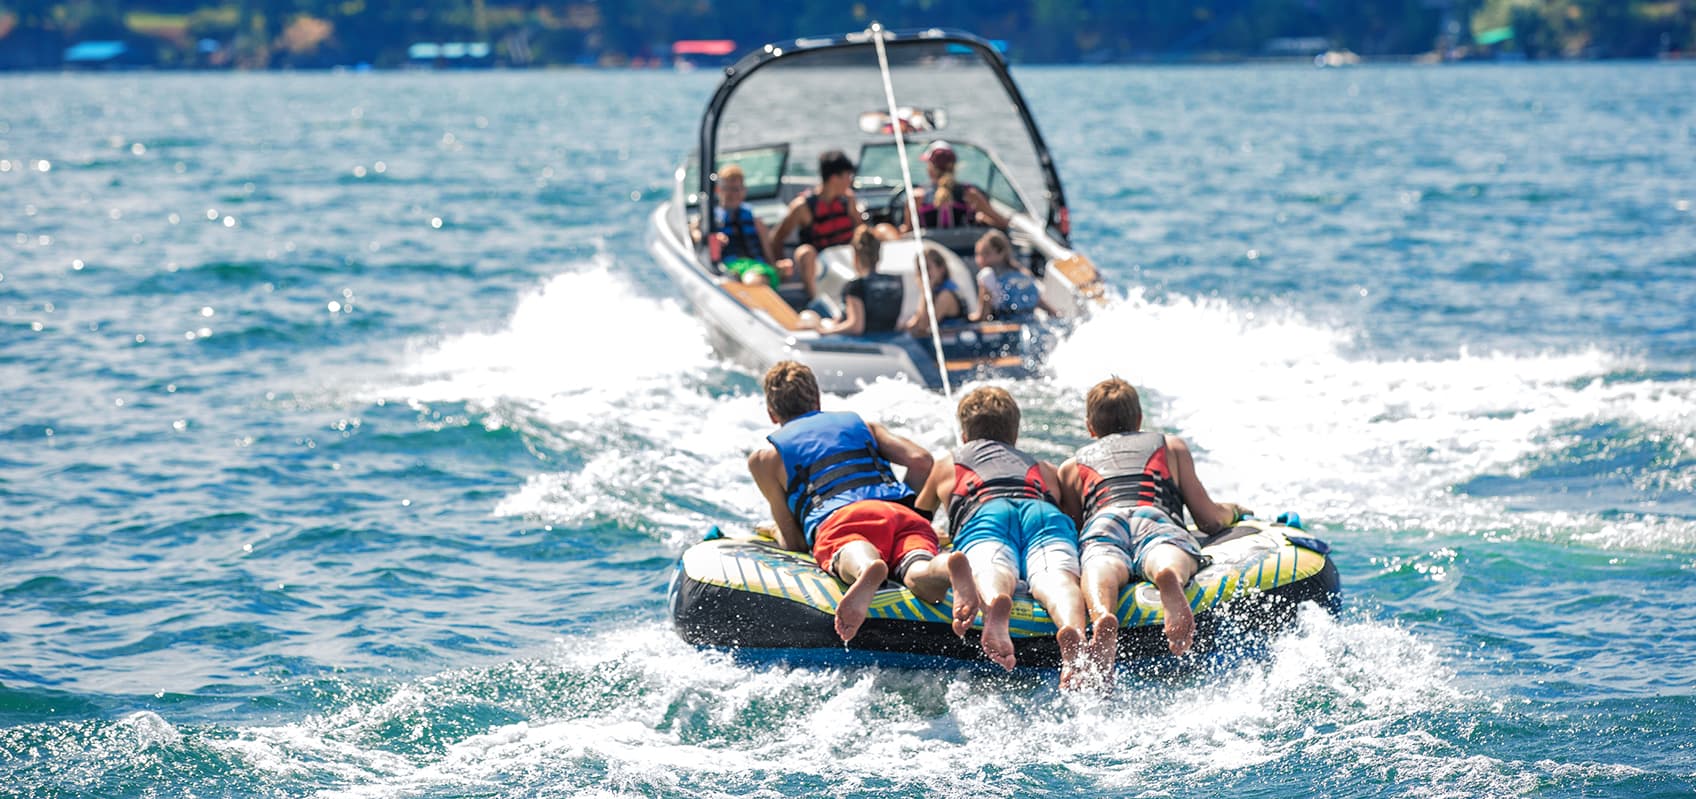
[765,411,912,546]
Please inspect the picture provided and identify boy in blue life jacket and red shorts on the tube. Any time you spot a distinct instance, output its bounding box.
[748,361,977,643]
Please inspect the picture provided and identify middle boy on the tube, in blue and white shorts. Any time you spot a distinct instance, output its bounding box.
[918,387,1085,687]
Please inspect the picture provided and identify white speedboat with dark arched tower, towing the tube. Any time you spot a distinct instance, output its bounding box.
[648,25,1102,394]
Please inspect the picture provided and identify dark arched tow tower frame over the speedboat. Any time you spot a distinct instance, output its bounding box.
[683,29,1068,246]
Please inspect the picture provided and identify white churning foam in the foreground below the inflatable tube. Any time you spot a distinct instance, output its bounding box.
[189,607,1573,797]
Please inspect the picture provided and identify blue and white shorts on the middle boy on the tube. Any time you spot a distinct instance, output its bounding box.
[953,499,1082,582]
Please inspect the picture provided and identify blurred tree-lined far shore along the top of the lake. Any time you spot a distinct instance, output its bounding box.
[0,0,1696,68]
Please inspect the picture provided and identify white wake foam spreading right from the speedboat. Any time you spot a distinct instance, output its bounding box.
[1050,292,1696,545]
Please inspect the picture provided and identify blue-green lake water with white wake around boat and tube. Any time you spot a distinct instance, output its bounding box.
[0,64,1696,797]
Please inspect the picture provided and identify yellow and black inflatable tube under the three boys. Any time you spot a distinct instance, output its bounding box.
[670,519,1338,667]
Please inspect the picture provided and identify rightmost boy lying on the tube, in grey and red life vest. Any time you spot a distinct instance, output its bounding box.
[1060,377,1250,675]
